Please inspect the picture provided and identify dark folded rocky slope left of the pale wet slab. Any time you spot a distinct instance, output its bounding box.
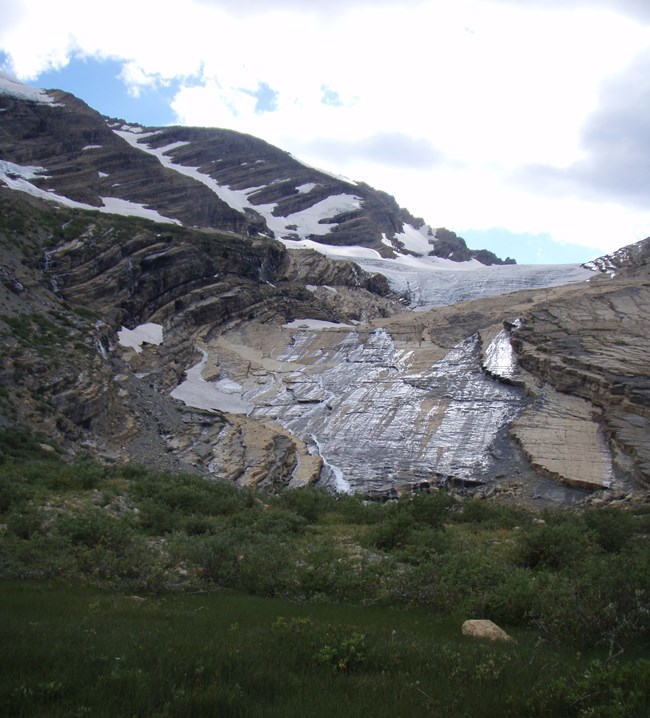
[0,190,399,488]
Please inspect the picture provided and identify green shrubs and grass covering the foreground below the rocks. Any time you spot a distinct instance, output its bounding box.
[0,429,650,718]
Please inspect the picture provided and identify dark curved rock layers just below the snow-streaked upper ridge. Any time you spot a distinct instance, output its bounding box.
[45,207,390,331]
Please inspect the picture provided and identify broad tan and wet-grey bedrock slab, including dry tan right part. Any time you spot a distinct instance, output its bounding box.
[162,282,632,499]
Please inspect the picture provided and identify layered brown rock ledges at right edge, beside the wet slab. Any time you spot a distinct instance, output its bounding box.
[512,267,650,490]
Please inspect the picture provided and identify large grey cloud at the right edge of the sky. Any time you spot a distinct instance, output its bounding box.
[520,52,650,209]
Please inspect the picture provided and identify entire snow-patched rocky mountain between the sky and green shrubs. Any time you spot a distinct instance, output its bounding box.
[0,78,650,502]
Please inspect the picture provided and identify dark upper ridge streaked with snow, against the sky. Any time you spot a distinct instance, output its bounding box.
[0,71,488,263]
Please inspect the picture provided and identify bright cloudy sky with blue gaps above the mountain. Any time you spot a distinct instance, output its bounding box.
[0,0,650,263]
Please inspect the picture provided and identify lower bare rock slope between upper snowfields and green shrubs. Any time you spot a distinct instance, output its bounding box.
[0,184,648,501]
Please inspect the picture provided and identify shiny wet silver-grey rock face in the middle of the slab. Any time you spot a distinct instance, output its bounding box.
[217,327,525,491]
